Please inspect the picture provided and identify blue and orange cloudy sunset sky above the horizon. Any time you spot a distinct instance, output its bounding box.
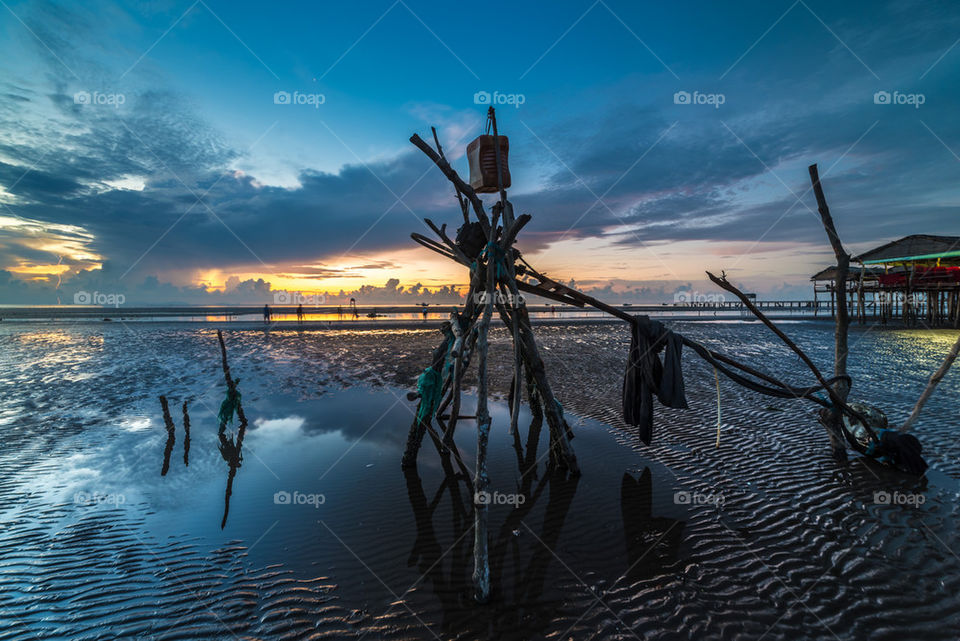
[0,0,960,305]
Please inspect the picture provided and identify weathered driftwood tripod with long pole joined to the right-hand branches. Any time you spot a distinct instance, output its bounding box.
[404,107,960,602]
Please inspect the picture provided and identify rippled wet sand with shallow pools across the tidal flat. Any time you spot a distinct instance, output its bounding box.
[0,323,960,639]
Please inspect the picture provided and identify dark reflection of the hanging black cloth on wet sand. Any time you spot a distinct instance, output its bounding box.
[620,467,685,580]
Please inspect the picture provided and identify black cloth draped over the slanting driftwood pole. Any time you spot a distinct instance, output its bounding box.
[623,317,687,445]
